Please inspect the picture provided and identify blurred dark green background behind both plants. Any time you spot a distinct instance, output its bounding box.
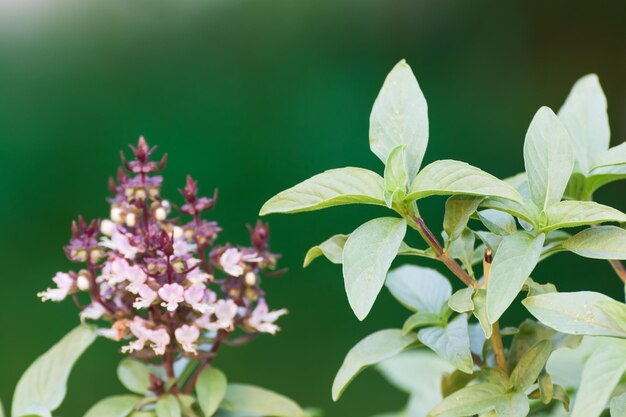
[0,0,626,417]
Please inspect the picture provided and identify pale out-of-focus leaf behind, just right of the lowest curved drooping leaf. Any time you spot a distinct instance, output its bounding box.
[376,349,454,394]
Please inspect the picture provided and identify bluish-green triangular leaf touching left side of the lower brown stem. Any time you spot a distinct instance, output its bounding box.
[417,314,474,374]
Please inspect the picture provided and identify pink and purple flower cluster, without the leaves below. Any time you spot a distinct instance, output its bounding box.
[38,138,286,358]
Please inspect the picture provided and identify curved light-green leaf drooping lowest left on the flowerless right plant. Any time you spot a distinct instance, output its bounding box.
[332,329,417,401]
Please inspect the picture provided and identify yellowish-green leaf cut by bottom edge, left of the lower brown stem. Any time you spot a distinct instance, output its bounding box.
[427,384,505,417]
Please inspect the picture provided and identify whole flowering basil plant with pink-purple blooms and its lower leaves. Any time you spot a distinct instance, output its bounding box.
[12,138,306,417]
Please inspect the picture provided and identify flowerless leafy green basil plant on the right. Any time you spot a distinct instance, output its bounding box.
[261,61,626,417]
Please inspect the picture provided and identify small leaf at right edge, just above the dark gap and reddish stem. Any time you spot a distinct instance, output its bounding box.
[562,226,626,259]
